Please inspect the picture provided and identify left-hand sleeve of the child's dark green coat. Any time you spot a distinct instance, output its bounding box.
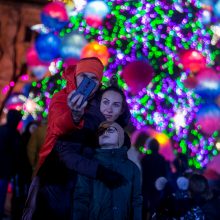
[73,175,92,220]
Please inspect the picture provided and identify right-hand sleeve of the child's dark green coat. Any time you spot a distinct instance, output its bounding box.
[132,165,142,220]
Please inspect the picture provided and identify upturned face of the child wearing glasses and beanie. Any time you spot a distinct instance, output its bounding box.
[99,126,119,149]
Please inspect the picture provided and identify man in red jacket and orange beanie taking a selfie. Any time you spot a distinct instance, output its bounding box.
[34,57,104,175]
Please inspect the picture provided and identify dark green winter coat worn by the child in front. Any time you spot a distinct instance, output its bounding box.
[73,147,142,220]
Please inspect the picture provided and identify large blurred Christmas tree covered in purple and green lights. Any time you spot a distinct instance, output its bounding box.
[28,0,218,168]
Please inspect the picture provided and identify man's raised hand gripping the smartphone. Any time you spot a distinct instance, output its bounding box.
[67,90,88,123]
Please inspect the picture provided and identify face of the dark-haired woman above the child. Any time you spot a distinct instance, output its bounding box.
[100,90,123,121]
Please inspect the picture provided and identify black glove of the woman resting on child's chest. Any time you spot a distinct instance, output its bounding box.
[96,165,127,189]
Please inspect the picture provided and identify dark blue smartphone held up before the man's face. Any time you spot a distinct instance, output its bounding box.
[71,77,96,106]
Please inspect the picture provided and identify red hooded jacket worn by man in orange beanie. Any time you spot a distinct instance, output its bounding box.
[34,66,84,174]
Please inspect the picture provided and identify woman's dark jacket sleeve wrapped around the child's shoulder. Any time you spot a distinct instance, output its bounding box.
[55,141,98,179]
